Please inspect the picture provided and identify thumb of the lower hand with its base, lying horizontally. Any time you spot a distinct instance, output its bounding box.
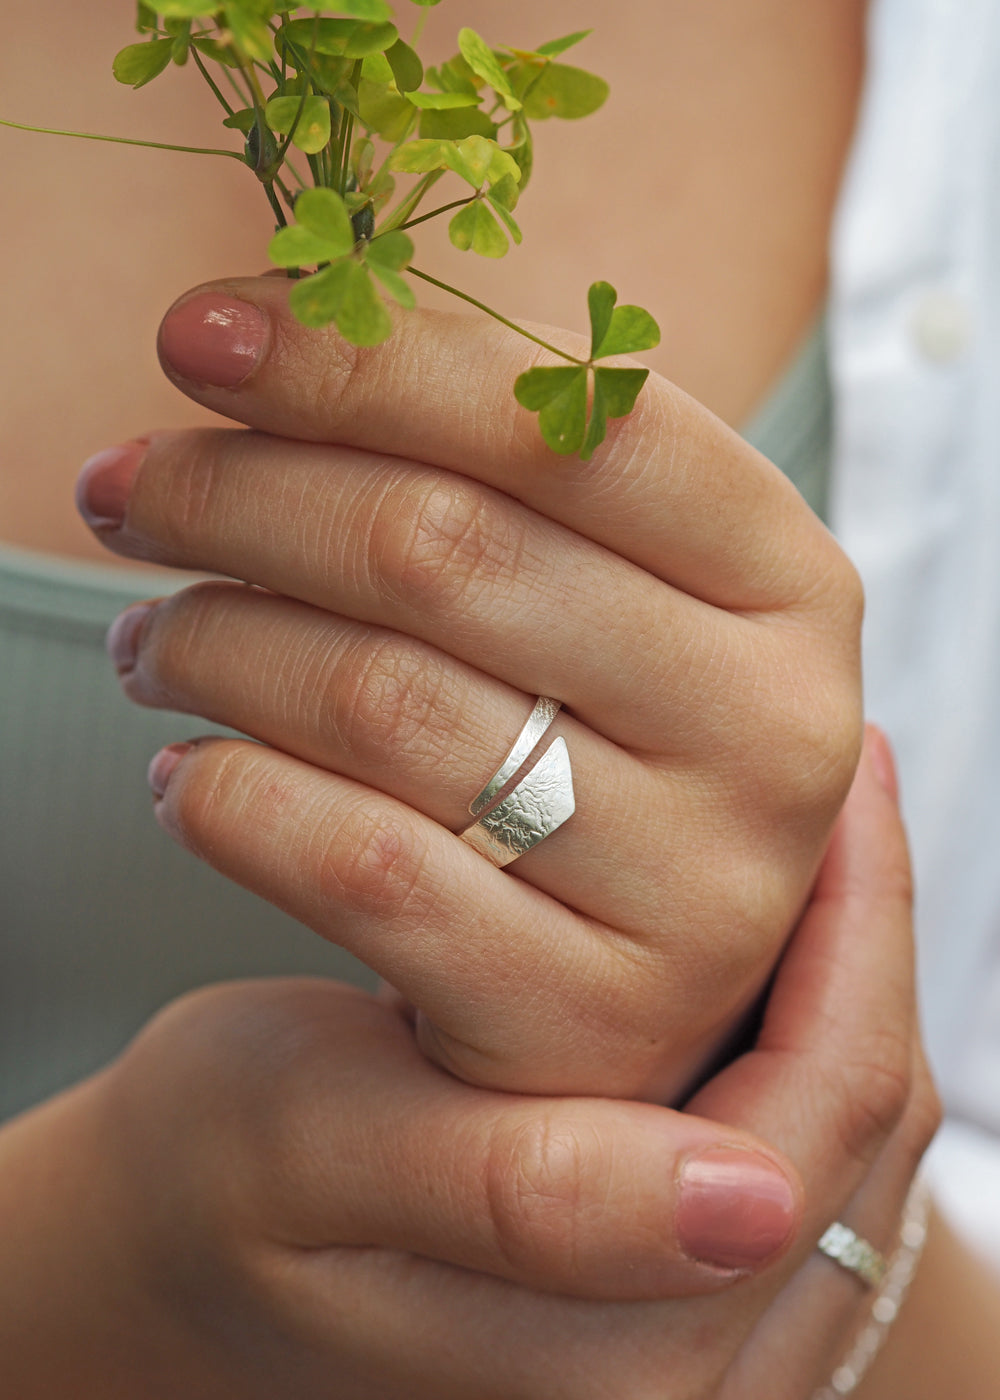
[163,981,800,1299]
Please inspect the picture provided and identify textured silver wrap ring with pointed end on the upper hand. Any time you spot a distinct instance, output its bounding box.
[458,696,576,867]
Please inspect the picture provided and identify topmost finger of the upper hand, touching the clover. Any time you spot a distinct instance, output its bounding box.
[160,279,845,609]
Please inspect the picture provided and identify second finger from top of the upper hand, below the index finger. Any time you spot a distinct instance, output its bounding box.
[81,431,767,759]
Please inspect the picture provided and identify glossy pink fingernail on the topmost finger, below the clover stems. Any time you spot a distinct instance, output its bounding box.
[160,291,268,389]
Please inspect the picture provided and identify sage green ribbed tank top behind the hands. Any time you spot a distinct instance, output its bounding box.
[0,326,831,1116]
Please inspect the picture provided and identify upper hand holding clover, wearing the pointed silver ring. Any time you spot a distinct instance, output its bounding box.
[81,279,860,1100]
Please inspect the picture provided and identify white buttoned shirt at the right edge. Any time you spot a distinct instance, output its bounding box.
[829,0,1000,1260]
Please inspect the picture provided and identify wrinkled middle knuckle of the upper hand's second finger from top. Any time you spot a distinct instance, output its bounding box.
[373,477,524,615]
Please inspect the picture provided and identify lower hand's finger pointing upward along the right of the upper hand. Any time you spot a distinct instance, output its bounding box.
[692,728,917,1235]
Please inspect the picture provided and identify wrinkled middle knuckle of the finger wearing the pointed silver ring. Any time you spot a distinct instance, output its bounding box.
[328,637,454,774]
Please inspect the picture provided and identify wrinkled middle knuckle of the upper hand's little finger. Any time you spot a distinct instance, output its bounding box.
[317,804,434,923]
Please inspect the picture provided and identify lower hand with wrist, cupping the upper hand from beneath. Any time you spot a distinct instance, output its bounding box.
[0,739,936,1400]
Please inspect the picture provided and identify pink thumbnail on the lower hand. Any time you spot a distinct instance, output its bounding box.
[675,1148,796,1270]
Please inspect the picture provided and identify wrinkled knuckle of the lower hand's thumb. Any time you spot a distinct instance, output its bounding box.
[485,1109,606,1281]
